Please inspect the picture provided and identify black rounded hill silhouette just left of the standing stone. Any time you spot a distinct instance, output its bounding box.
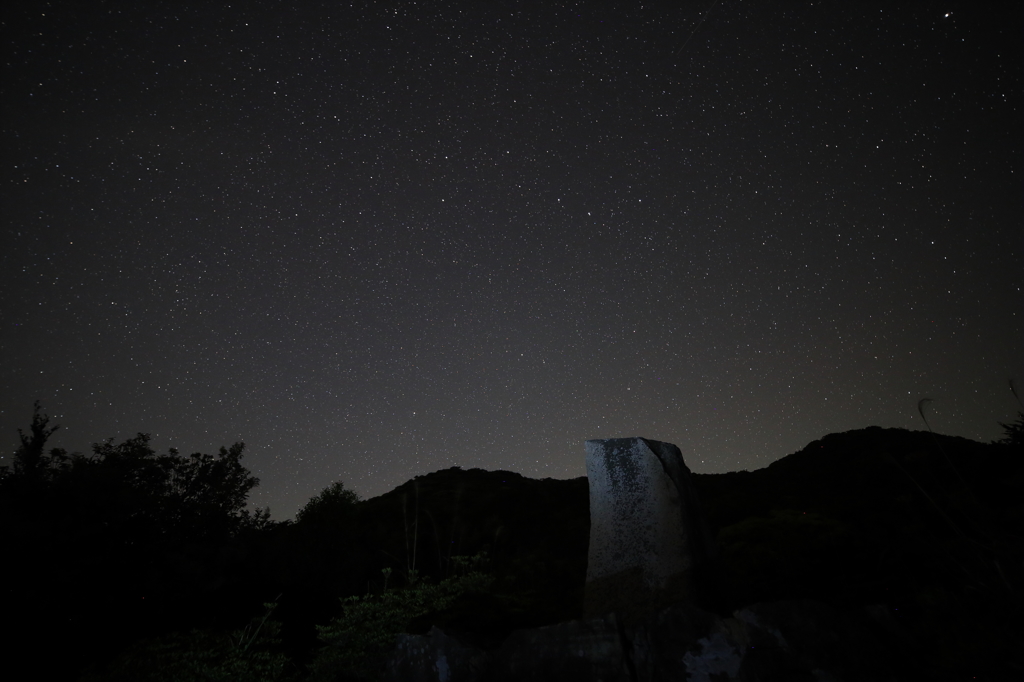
[359,468,590,622]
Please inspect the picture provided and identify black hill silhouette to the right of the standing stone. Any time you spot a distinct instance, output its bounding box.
[696,427,1024,679]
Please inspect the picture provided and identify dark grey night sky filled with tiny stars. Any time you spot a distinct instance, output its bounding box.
[0,0,1024,519]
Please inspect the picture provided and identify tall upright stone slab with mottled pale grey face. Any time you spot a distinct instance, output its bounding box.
[584,438,711,624]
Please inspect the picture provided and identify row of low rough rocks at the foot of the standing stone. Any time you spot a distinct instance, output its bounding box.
[384,600,895,682]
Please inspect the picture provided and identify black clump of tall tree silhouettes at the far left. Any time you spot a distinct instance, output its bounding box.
[0,402,268,679]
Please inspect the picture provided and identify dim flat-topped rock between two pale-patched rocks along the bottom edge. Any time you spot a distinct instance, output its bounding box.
[487,613,631,682]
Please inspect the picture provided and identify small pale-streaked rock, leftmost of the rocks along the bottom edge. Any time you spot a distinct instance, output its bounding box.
[384,627,490,682]
